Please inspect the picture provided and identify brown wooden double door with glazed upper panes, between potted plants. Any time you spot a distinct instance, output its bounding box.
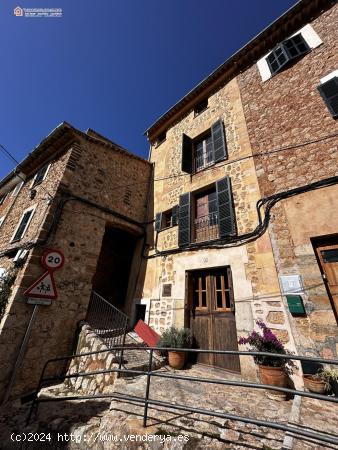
[187,268,240,372]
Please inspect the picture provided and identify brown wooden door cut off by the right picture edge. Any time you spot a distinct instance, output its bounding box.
[315,237,338,322]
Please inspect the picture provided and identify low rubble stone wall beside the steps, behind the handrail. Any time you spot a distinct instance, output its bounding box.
[65,324,118,395]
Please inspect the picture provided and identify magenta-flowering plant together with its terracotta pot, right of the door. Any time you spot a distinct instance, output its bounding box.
[238,320,295,399]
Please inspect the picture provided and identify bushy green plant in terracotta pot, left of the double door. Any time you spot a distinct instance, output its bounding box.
[157,327,192,369]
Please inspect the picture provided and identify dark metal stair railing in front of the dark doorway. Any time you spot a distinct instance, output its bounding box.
[85,291,128,349]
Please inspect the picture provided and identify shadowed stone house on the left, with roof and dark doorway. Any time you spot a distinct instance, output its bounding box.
[0,123,152,397]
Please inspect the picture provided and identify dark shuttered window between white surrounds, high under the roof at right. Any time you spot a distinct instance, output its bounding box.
[266,33,309,74]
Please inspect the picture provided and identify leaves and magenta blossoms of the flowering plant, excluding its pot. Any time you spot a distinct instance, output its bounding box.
[238,320,295,373]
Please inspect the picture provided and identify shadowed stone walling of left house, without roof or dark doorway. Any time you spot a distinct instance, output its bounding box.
[0,130,151,396]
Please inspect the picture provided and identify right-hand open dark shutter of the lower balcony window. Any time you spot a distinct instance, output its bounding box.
[216,177,236,238]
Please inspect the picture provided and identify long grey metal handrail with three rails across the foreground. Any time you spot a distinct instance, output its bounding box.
[27,346,338,444]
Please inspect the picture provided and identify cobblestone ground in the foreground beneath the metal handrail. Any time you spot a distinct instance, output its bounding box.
[0,366,338,450]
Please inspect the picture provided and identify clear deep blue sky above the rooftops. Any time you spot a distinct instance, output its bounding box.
[0,0,296,178]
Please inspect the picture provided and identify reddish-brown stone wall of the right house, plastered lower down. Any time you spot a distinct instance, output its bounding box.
[238,4,338,358]
